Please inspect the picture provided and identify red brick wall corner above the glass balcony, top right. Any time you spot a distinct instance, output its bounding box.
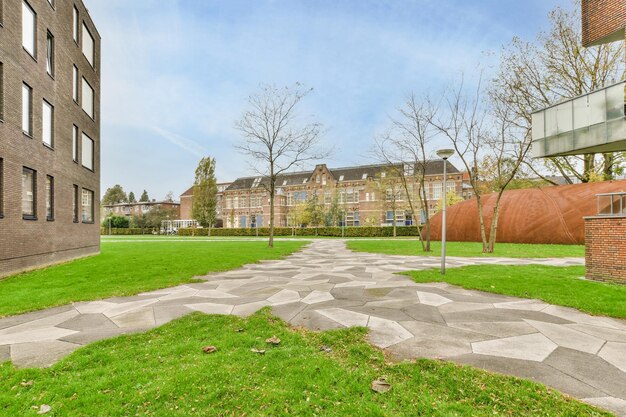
[582,0,626,46]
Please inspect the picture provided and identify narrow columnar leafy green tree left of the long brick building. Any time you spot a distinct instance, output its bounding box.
[191,157,217,236]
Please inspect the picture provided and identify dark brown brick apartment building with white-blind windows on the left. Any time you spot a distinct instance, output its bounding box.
[0,0,100,276]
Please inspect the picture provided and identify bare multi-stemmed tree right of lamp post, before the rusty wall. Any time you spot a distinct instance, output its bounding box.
[430,78,531,253]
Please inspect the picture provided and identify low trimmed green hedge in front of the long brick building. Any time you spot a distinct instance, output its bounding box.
[178,226,418,237]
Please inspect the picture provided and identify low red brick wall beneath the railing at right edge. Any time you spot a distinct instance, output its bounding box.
[585,216,626,284]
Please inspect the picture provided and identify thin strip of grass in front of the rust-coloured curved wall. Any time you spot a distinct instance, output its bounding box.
[347,240,585,258]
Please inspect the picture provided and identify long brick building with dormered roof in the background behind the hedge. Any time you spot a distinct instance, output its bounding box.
[181,160,462,228]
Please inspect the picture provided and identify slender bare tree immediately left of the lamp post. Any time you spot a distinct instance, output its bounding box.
[375,93,437,252]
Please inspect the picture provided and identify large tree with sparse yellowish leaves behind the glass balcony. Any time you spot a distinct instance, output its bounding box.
[489,0,625,183]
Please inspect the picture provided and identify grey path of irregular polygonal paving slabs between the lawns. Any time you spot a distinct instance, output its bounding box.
[0,240,626,416]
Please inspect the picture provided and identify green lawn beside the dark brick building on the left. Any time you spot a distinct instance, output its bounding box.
[0,241,308,317]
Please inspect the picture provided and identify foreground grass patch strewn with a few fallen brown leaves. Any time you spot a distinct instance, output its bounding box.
[0,310,611,417]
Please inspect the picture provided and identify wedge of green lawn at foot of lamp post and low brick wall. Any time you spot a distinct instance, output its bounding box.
[406,265,626,319]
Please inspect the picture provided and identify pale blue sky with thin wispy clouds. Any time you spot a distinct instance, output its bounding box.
[85,0,573,202]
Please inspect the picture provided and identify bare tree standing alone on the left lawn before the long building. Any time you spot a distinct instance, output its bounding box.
[235,83,328,247]
